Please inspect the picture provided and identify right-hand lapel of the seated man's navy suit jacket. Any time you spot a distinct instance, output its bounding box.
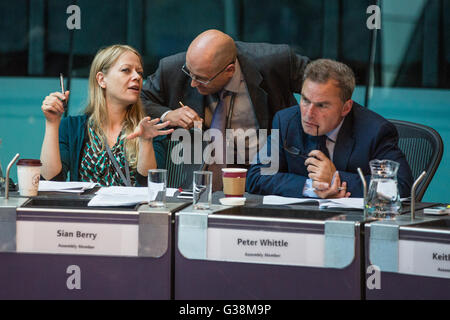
[333,112,355,170]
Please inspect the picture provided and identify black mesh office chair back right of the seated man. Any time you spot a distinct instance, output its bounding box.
[389,119,444,201]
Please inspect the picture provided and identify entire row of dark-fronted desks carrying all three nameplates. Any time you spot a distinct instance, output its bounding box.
[0,192,450,299]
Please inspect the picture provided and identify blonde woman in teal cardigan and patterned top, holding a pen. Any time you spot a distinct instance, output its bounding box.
[41,45,173,186]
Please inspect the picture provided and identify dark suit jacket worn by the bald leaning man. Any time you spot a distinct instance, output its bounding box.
[141,42,309,129]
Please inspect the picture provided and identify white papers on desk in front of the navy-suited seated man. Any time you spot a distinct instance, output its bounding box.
[263,196,364,210]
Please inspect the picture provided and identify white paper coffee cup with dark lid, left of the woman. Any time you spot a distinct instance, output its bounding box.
[17,159,42,197]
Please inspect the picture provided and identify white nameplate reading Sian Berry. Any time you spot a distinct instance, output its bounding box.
[16,221,139,257]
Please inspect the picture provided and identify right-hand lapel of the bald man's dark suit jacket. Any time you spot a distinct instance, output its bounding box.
[237,47,271,128]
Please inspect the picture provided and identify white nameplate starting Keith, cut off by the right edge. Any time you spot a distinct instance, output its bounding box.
[398,240,450,278]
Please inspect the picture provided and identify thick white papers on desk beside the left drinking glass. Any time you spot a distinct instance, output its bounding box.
[88,187,177,207]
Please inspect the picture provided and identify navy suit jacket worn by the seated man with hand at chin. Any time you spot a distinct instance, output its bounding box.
[247,102,413,197]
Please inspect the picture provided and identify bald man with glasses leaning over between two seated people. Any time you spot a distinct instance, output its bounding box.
[141,30,309,189]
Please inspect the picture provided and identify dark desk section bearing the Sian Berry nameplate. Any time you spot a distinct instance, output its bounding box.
[0,194,189,299]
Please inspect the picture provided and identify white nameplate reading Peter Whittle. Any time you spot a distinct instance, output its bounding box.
[207,228,325,267]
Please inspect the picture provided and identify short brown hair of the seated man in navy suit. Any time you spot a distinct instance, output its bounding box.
[303,59,355,102]
